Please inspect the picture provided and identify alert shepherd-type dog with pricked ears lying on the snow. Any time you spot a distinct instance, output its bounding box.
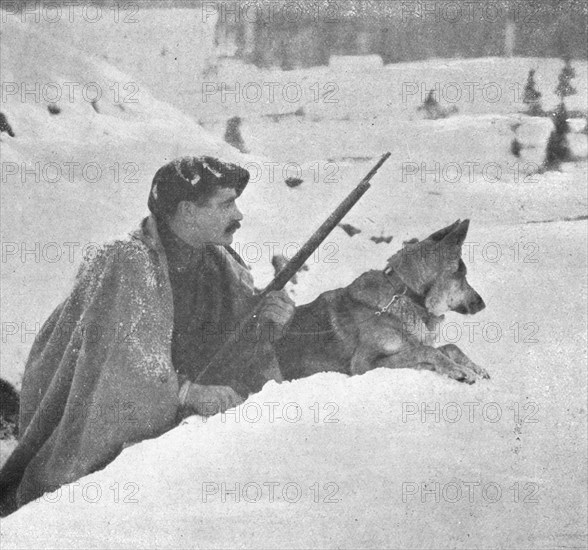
[274,220,489,384]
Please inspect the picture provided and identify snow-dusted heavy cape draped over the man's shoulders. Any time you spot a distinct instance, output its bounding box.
[0,217,254,511]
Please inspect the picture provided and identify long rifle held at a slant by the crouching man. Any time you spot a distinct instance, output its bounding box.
[195,153,391,393]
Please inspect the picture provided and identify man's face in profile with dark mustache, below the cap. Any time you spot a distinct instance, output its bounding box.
[184,187,243,245]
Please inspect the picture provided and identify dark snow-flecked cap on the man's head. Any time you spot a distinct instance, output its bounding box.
[147,157,249,217]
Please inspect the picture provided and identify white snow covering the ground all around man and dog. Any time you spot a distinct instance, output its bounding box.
[0,5,588,548]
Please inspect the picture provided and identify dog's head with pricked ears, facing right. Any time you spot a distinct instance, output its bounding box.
[388,220,486,315]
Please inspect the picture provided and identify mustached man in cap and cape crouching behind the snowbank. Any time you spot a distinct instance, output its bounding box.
[0,157,294,513]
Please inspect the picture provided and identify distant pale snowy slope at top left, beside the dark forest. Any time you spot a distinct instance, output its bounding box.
[6,2,217,111]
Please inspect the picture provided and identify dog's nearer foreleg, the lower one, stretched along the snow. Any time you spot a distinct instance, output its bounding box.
[370,346,477,384]
